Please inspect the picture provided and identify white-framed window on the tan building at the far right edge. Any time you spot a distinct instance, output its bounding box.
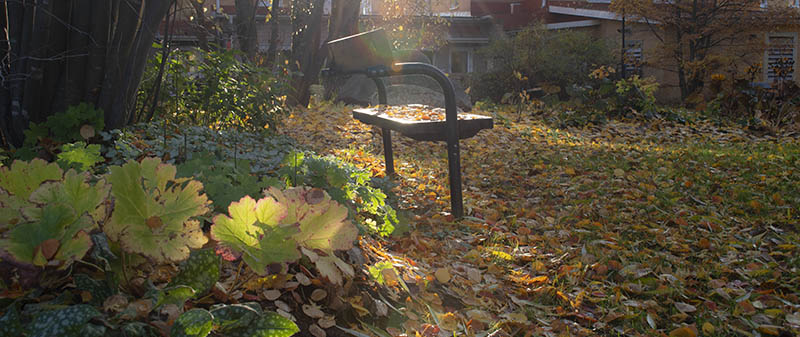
[764,33,797,83]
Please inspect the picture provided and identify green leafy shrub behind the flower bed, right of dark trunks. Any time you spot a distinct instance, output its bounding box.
[137,50,286,131]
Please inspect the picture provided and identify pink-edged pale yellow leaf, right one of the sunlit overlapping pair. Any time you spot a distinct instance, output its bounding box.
[269,187,358,253]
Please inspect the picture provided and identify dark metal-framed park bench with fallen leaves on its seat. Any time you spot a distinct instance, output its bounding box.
[323,29,493,218]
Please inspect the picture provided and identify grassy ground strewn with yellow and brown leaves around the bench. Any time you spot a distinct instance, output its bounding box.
[284,105,800,336]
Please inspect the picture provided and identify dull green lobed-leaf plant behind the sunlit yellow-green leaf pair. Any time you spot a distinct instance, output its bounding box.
[178,152,280,211]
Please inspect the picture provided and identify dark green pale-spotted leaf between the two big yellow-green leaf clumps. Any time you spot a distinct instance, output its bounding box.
[170,248,221,296]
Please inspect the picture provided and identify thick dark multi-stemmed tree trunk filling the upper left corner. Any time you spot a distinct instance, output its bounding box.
[0,0,170,146]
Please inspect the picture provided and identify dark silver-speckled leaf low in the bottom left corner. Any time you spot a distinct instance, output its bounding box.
[29,304,101,337]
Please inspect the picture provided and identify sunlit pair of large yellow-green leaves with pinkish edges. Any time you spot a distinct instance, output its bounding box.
[211,187,358,275]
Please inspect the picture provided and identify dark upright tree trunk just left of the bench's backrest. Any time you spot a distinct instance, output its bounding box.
[287,0,325,106]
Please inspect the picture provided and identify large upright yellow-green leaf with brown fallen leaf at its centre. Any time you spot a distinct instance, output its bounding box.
[103,158,209,263]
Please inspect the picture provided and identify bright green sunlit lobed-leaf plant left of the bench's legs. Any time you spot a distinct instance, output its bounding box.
[279,152,398,236]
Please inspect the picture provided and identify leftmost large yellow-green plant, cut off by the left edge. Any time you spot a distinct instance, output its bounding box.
[0,159,109,269]
